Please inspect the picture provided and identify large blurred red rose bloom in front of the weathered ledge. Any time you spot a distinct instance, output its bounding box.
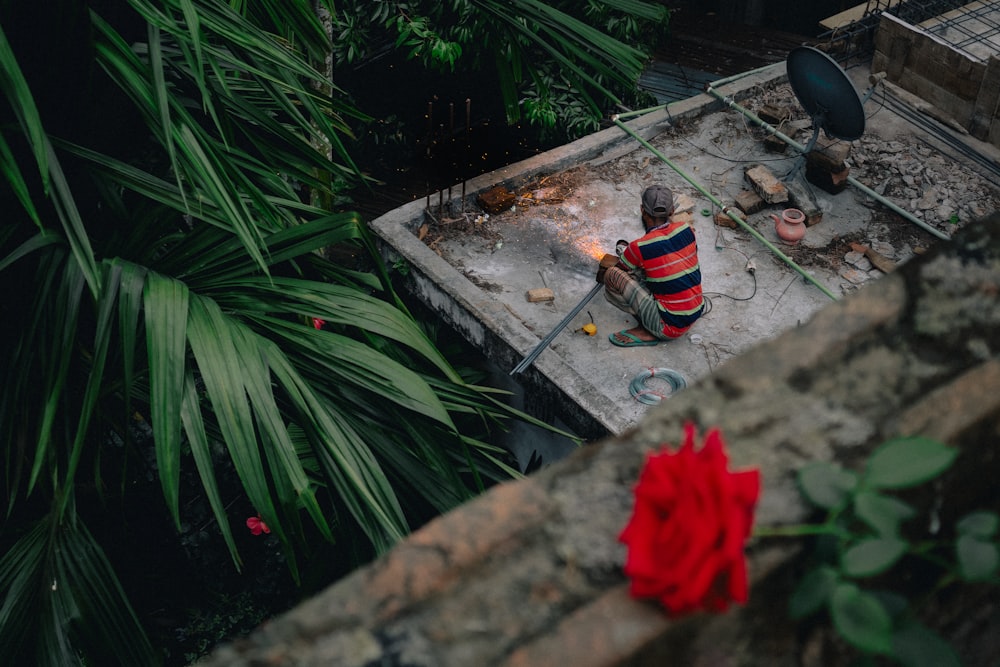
[618,424,760,615]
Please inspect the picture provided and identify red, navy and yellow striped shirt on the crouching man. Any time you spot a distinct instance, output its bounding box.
[621,221,704,329]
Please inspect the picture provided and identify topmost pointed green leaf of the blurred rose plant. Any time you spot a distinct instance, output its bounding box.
[864,437,958,489]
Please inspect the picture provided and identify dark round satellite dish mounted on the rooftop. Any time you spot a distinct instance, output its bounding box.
[786,46,865,147]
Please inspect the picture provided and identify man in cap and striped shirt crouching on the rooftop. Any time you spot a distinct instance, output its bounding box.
[604,185,704,347]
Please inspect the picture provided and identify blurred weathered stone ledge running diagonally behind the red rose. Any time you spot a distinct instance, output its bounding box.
[201,216,1000,667]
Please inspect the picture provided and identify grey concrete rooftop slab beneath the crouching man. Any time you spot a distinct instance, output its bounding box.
[372,56,1000,460]
